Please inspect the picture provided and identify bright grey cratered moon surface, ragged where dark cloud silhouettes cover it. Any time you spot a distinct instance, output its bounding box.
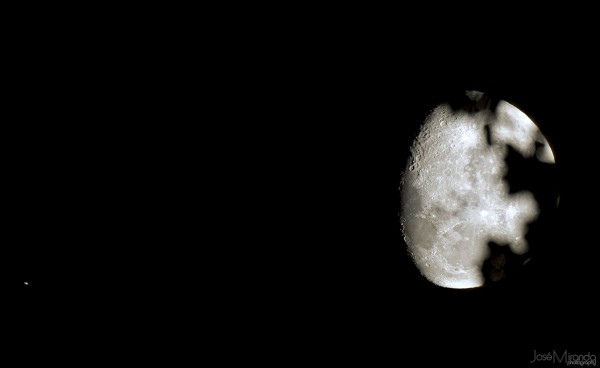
[400,91,554,289]
